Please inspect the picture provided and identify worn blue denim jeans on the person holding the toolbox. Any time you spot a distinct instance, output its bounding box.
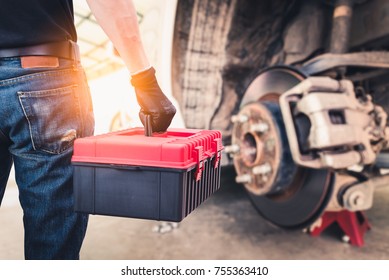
[0,58,94,259]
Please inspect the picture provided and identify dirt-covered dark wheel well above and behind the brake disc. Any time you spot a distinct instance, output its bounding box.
[172,0,389,143]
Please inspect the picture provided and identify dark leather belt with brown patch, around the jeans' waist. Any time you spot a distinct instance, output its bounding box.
[0,41,80,61]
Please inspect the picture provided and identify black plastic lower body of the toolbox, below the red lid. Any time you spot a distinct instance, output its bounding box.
[73,159,221,222]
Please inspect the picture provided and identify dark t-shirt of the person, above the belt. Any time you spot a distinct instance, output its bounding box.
[0,0,77,48]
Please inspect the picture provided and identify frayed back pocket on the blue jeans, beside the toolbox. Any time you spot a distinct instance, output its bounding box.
[18,86,82,154]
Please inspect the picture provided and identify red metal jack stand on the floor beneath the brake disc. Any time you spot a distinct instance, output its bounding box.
[310,210,371,247]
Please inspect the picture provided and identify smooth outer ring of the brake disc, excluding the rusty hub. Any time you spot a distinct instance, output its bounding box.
[238,67,333,229]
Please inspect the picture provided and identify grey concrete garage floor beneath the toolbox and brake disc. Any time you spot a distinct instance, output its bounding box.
[0,168,389,260]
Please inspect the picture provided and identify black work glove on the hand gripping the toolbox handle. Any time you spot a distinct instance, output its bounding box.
[131,67,176,132]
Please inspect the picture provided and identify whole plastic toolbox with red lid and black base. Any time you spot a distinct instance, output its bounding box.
[72,128,223,222]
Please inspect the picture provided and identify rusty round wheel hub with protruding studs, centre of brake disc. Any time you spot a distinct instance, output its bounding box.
[232,102,296,195]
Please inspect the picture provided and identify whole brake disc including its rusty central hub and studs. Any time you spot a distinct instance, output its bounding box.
[232,67,333,229]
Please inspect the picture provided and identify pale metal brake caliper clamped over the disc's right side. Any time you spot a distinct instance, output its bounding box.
[280,77,387,169]
